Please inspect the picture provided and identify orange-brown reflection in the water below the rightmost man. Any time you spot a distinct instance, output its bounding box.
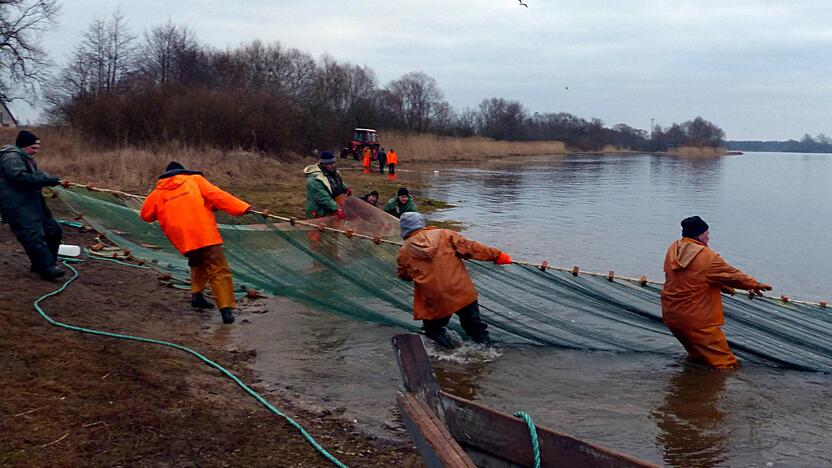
[652,363,732,466]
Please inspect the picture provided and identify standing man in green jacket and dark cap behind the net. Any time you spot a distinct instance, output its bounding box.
[303,151,352,219]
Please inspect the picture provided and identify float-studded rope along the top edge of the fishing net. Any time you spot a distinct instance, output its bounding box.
[61,181,828,309]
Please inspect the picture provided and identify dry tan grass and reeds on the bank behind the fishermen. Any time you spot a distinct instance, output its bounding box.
[0,128,557,217]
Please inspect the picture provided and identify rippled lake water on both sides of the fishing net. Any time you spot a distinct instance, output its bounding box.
[235,153,832,467]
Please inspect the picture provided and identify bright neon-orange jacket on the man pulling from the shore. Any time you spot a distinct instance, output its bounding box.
[141,171,251,254]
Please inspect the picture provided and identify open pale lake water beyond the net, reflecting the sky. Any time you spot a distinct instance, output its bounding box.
[425,153,832,300]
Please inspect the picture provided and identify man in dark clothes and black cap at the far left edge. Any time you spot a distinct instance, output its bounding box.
[0,130,64,280]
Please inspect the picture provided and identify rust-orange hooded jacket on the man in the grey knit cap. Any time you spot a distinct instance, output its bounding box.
[396,227,500,320]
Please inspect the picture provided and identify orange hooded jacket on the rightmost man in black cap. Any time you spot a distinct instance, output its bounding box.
[661,237,759,329]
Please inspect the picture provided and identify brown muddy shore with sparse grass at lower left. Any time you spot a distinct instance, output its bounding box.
[0,225,420,466]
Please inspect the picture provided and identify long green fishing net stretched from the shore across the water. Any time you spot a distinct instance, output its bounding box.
[58,189,832,372]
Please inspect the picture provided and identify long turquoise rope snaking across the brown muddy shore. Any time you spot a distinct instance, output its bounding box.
[34,260,347,468]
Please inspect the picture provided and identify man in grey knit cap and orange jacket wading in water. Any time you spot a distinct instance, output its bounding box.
[396,212,511,348]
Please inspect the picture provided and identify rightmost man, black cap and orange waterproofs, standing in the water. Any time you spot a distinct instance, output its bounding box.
[661,216,771,368]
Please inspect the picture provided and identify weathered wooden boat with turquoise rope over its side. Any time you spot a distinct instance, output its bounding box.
[393,334,657,468]
